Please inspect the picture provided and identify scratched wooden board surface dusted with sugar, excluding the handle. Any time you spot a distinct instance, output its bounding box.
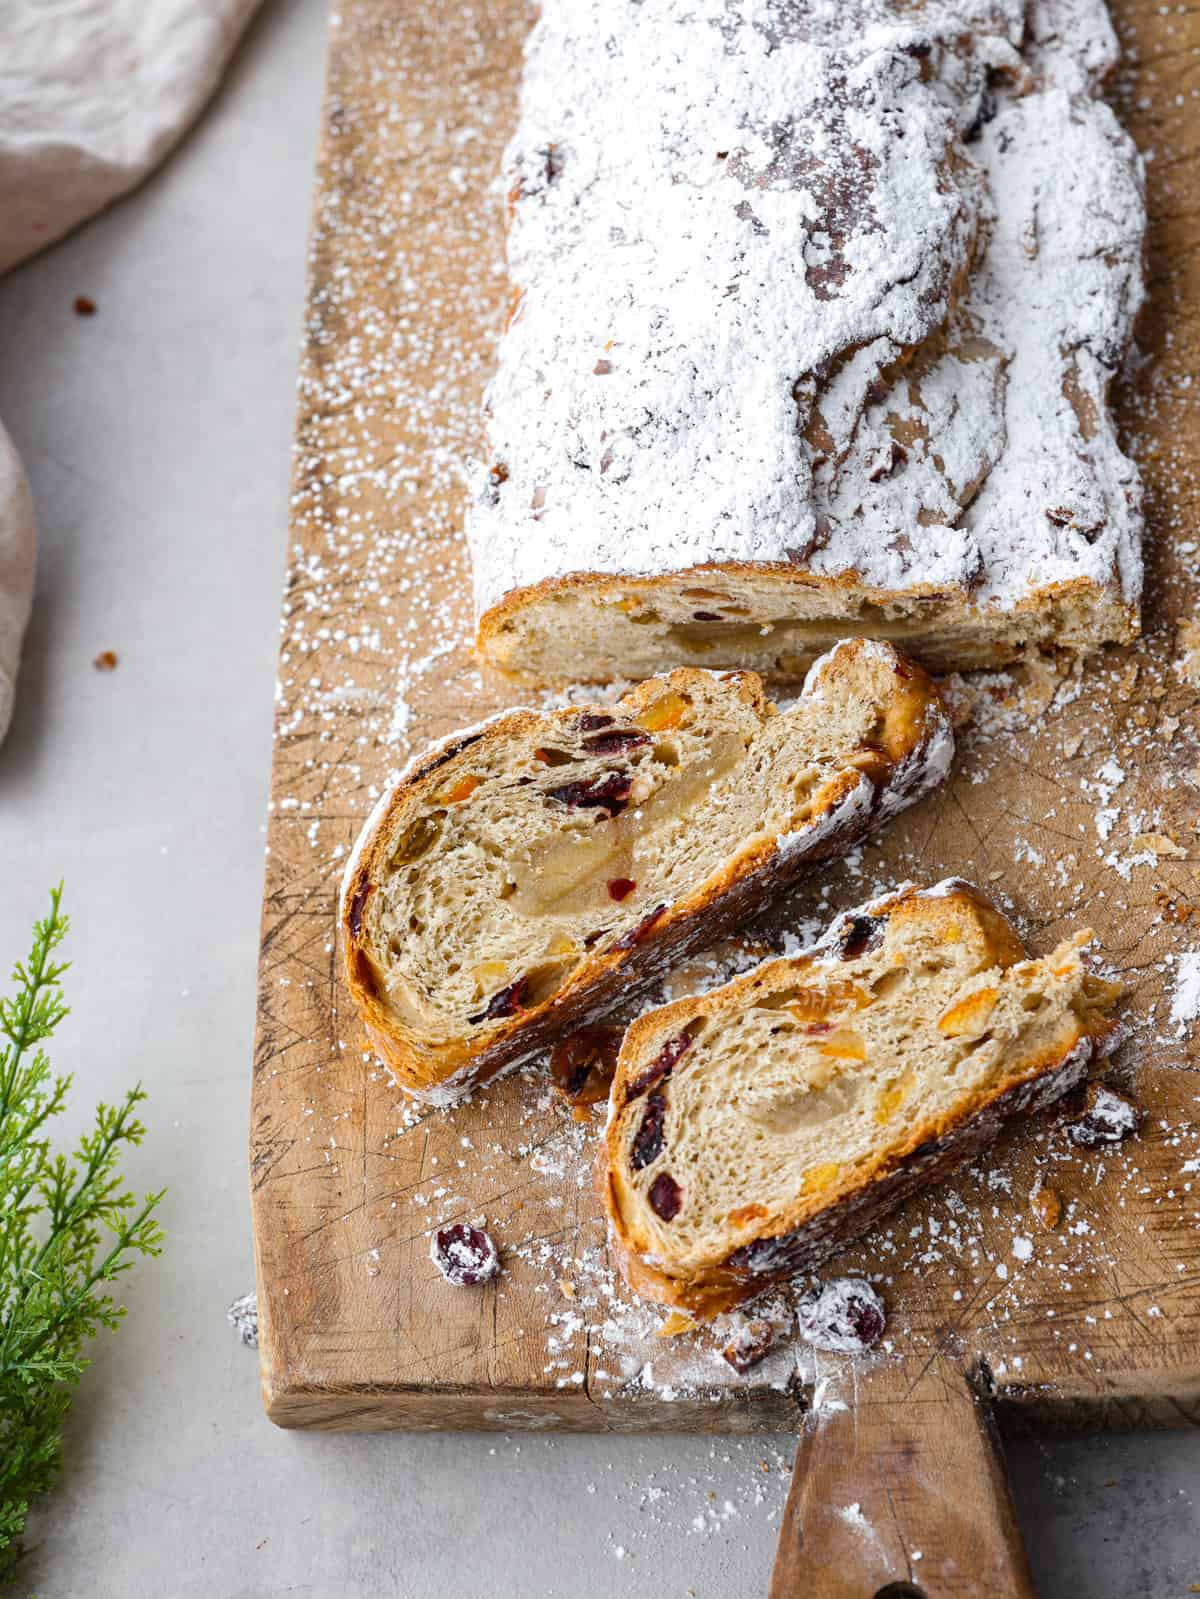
[251,0,1200,1431]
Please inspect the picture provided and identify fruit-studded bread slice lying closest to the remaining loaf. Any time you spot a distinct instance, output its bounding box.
[341,640,954,1100]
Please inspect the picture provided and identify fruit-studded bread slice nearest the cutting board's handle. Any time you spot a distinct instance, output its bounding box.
[602,879,1120,1318]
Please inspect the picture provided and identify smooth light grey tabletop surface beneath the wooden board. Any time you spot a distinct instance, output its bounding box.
[0,0,1200,1599]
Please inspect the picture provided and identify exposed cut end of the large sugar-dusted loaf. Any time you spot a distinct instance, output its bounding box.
[478,566,1139,686]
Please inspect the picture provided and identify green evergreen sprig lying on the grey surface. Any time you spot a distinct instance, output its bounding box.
[0,884,163,1585]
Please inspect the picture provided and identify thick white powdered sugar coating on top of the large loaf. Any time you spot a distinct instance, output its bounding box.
[467,0,1144,636]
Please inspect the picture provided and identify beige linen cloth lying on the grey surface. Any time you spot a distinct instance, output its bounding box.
[0,0,259,739]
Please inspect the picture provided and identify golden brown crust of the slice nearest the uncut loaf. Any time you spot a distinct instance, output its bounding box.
[339,640,949,1097]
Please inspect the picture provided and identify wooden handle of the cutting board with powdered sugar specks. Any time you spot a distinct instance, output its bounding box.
[770,1353,1037,1599]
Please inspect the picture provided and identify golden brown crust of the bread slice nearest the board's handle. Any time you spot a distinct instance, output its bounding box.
[595,881,1117,1319]
